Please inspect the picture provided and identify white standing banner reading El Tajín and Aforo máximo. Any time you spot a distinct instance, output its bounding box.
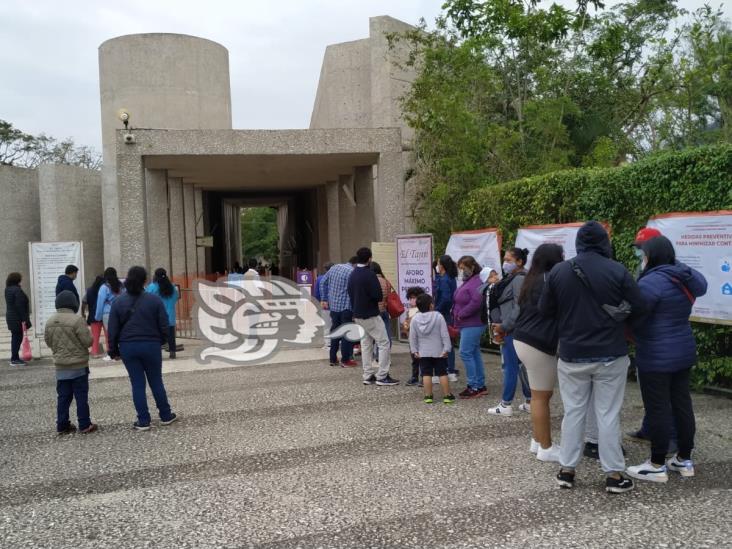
[396,234,432,309]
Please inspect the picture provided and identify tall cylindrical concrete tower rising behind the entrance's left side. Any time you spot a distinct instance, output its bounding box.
[99,33,231,266]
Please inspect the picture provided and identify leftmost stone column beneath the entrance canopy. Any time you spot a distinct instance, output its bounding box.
[145,169,171,273]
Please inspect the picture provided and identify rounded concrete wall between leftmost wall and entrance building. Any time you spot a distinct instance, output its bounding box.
[38,164,104,285]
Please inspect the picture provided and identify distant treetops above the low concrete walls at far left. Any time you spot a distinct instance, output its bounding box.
[0,120,102,170]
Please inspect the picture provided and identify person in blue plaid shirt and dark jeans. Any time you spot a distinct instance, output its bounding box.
[320,256,358,368]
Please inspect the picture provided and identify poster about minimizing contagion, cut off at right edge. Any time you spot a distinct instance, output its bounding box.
[648,211,732,325]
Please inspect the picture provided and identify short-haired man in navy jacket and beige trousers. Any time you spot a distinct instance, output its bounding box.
[348,248,399,385]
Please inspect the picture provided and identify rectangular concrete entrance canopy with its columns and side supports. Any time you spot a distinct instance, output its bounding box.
[116,128,405,276]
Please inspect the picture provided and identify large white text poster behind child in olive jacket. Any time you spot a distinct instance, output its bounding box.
[28,242,85,338]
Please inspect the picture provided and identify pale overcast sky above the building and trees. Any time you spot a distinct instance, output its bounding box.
[0,0,729,150]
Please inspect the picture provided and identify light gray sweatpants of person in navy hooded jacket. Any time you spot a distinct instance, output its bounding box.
[557,356,630,473]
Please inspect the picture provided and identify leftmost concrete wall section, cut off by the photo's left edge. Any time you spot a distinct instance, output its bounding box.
[0,166,41,314]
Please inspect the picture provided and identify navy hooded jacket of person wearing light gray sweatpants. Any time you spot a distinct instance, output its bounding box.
[539,221,645,362]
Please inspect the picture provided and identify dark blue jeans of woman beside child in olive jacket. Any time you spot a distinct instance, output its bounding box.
[119,341,173,425]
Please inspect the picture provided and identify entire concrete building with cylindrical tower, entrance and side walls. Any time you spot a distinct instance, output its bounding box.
[0,17,414,308]
